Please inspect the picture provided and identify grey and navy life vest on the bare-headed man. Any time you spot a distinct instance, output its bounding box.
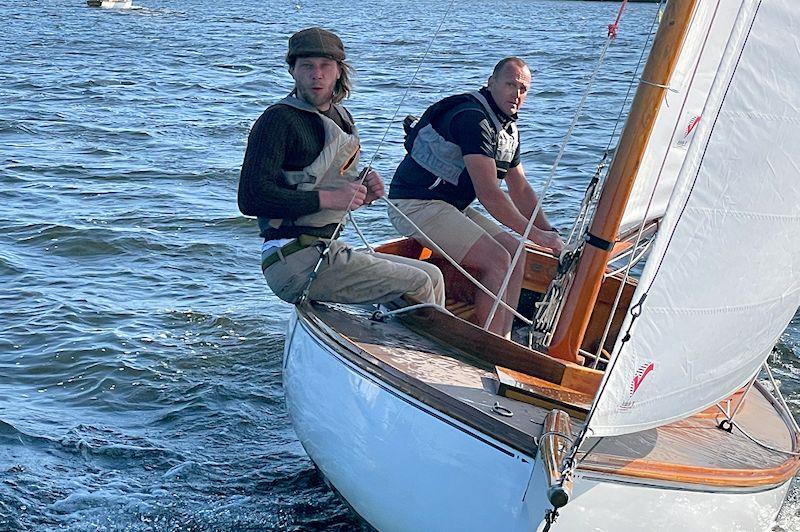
[405,91,519,189]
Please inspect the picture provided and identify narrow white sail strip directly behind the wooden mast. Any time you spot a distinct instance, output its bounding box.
[619,0,742,233]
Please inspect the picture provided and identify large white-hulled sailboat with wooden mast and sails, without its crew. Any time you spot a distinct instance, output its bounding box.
[283,0,800,531]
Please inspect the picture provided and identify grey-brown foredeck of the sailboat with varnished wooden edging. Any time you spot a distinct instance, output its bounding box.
[305,304,798,489]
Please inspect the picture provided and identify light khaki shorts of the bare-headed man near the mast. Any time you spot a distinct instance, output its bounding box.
[389,199,506,263]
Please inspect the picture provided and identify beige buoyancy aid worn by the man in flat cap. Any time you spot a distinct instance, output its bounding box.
[258,96,361,238]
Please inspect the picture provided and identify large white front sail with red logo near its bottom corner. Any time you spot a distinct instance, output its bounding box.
[589,0,800,436]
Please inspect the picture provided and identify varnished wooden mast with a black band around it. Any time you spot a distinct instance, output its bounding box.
[548,0,699,362]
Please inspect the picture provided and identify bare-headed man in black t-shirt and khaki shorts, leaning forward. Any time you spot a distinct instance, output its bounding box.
[389,57,562,335]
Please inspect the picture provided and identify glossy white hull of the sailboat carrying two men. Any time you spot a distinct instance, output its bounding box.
[283,314,789,532]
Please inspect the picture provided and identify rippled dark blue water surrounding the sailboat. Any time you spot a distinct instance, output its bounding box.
[0,0,800,530]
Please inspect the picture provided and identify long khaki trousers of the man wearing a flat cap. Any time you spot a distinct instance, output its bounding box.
[262,240,445,305]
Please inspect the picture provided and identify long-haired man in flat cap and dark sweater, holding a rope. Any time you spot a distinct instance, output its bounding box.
[238,28,444,305]
